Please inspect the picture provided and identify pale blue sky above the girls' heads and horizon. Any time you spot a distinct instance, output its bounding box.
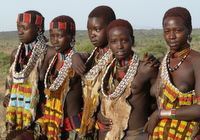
[0,0,200,31]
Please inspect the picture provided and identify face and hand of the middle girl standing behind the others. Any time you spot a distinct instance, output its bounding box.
[72,17,108,76]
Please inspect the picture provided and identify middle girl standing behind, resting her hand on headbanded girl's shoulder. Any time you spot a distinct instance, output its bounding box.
[73,5,115,139]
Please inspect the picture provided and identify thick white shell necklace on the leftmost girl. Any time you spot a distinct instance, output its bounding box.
[12,35,47,83]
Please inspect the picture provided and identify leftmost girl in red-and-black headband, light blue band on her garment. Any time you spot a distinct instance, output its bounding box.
[3,10,47,137]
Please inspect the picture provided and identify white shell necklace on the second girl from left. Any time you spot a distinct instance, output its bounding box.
[44,49,74,91]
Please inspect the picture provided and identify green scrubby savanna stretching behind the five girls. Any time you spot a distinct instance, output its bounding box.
[0,29,200,139]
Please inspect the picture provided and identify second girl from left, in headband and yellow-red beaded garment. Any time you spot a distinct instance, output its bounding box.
[35,15,82,140]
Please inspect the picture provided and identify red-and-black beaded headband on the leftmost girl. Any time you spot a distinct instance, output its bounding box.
[17,13,44,26]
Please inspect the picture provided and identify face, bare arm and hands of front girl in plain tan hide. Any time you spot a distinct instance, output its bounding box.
[98,26,158,139]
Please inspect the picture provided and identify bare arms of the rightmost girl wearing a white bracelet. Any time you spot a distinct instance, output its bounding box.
[145,56,200,133]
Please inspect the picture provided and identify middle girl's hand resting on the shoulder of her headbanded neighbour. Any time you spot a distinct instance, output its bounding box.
[72,53,86,76]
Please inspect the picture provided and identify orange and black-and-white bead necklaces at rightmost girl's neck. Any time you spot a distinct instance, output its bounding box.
[167,48,191,72]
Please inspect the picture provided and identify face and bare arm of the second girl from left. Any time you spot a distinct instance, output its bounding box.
[50,29,83,139]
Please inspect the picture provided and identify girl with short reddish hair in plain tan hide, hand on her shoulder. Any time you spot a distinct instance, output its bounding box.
[98,19,158,140]
